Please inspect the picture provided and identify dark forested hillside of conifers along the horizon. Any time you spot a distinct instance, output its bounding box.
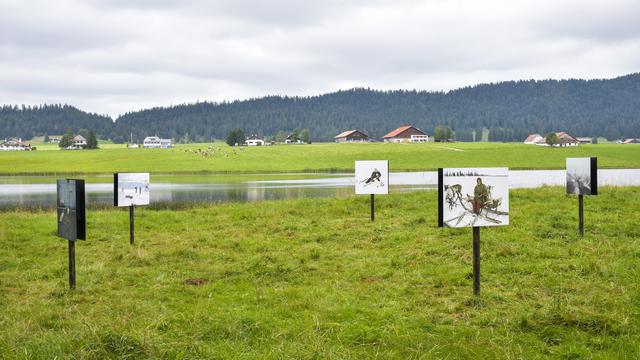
[0,74,640,142]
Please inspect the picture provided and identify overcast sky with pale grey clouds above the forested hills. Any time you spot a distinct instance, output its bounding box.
[0,0,640,117]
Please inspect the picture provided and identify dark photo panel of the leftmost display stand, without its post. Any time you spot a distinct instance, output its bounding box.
[57,179,85,241]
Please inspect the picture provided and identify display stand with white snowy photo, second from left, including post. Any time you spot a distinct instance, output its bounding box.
[113,173,149,246]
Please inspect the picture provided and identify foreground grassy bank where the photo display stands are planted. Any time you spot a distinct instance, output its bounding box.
[0,188,640,359]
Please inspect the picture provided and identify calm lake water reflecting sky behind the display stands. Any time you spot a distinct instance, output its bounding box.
[0,169,640,208]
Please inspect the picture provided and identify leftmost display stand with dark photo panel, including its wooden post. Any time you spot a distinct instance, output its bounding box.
[56,179,86,289]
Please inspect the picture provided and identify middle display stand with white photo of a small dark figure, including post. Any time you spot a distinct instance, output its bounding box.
[355,160,389,221]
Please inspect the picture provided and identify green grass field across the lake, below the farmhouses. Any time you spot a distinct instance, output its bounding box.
[0,143,640,174]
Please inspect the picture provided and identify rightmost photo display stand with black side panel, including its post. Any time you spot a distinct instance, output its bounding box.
[567,157,598,236]
